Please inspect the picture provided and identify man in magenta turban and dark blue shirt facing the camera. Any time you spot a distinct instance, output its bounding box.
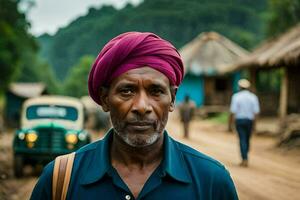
[31,32,238,200]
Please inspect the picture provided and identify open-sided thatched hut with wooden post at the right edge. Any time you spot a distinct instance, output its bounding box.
[231,24,300,120]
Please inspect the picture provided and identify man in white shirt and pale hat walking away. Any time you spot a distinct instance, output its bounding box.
[229,79,260,167]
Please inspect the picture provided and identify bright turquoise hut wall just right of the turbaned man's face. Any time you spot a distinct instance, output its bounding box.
[176,74,204,107]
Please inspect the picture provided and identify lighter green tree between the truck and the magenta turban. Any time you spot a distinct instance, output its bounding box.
[62,55,95,97]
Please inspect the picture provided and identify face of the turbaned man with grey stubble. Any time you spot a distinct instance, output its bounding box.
[101,67,175,147]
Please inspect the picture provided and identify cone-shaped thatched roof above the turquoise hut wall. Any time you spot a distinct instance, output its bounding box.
[179,32,248,76]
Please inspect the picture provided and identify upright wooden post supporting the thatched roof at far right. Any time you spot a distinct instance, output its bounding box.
[279,67,288,122]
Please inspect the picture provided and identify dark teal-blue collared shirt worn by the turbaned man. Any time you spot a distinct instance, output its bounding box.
[31,129,238,200]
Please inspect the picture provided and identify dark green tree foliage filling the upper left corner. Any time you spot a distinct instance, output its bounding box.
[0,0,37,92]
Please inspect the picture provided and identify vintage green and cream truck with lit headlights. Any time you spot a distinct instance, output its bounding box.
[13,96,90,177]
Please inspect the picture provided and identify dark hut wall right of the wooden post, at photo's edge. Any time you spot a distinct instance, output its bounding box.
[287,67,300,114]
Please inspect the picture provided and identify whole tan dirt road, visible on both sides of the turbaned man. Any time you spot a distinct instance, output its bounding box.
[0,117,300,200]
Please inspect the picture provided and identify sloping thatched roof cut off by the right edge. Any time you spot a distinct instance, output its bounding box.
[232,24,300,70]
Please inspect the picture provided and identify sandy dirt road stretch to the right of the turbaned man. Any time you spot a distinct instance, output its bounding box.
[167,115,300,200]
